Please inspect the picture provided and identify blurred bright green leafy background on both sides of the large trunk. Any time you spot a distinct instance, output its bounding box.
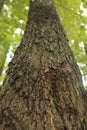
[0,0,87,88]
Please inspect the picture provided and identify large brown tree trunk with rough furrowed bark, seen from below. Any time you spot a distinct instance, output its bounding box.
[0,0,87,130]
